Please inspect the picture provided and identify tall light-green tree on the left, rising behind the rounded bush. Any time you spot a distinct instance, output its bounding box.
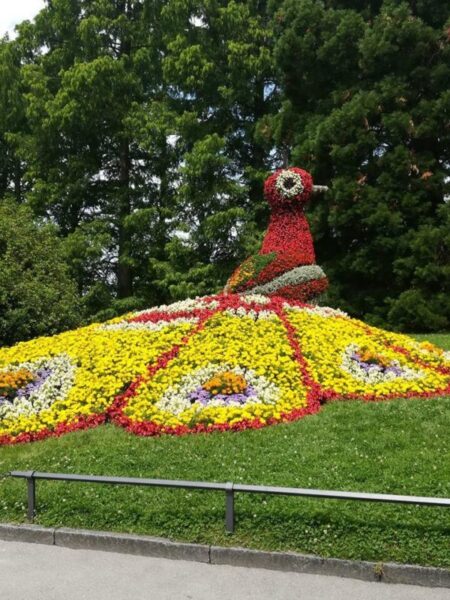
[11,0,175,304]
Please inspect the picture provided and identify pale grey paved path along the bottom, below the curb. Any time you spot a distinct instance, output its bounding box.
[0,541,450,600]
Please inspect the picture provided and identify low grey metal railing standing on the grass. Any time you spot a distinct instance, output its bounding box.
[10,471,450,533]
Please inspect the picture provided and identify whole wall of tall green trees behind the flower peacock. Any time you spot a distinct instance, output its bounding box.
[0,0,450,330]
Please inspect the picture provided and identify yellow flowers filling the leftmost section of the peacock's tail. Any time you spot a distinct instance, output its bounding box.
[0,319,192,436]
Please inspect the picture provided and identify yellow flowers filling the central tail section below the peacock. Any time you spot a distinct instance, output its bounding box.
[125,313,307,427]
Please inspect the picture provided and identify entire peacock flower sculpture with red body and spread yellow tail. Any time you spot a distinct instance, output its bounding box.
[0,168,450,444]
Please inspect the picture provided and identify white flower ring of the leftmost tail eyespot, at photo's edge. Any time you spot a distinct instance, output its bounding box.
[0,354,76,420]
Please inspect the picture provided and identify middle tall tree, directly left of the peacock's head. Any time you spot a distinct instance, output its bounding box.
[152,0,279,298]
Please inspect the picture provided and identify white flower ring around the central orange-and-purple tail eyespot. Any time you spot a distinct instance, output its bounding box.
[156,364,280,415]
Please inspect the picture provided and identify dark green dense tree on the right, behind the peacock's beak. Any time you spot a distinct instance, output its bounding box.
[274,0,450,330]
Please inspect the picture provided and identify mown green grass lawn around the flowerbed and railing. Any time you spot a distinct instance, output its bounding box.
[0,334,450,567]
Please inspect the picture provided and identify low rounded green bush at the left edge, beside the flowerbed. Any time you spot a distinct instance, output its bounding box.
[0,200,80,345]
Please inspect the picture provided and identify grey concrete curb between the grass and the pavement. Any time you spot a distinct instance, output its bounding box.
[0,523,450,588]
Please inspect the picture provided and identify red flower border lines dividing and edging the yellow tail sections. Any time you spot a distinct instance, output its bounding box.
[0,295,450,446]
